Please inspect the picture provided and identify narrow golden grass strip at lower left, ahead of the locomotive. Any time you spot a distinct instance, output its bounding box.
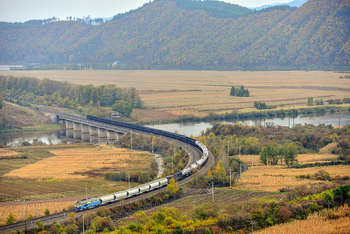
[0,200,75,225]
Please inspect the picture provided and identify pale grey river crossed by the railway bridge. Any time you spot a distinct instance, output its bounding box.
[0,113,350,146]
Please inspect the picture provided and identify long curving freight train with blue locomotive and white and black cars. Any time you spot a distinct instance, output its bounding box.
[75,115,209,212]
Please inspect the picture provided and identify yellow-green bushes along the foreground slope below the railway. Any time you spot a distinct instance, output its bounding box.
[40,185,350,234]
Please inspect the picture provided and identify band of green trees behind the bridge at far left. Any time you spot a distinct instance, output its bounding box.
[0,76,142,116]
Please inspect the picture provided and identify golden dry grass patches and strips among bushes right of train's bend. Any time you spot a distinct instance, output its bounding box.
[239,154,350,192]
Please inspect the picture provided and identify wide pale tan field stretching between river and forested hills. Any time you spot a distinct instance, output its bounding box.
[0,70,350,120]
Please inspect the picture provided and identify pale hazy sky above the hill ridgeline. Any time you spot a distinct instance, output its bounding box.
[0,0,292,22]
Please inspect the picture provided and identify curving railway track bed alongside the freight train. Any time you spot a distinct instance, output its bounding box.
[0,119,214,233]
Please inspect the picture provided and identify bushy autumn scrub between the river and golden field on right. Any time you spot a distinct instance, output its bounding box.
[201,124,350,157]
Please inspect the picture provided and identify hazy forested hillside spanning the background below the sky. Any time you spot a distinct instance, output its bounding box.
[0,0,350,69]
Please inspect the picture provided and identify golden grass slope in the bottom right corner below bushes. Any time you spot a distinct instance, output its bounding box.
[254,206,350,234]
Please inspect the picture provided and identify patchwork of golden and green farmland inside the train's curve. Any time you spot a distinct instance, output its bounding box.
[0,144,154,224]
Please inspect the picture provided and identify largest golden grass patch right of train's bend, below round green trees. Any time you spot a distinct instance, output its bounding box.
[239,165,350,192]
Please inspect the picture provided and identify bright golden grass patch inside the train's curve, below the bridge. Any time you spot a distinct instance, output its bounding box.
[4,145,153,179]
